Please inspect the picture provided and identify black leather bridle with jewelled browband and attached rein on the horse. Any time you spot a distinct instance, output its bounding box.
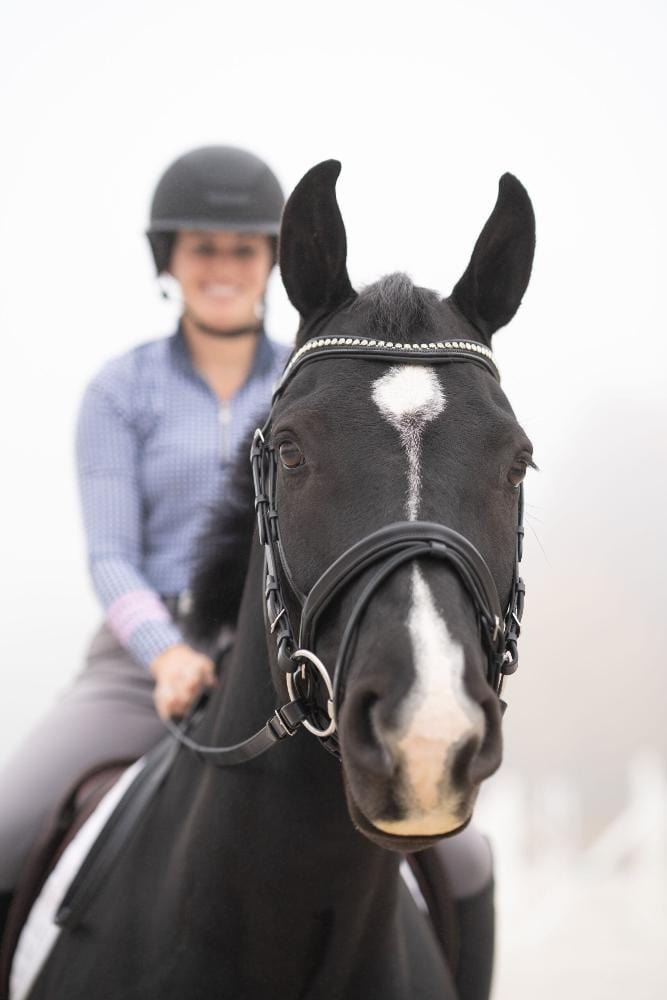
[167,330,525,766]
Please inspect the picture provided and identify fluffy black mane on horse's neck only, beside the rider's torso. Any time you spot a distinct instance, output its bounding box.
[185,420,264,643]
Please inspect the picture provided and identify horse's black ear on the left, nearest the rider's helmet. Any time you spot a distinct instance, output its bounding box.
[279,160,354,320]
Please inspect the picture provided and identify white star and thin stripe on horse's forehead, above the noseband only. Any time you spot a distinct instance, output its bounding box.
[373,365,445,521]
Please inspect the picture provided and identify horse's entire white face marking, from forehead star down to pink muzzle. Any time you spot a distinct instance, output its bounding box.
[373,365,484,836]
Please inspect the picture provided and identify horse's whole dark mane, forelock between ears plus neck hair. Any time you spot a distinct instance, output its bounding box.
[185,273,442,642]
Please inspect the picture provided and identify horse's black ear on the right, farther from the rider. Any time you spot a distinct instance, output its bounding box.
[452,174,535,343]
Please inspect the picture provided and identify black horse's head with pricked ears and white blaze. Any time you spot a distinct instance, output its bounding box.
[258,161,534,850]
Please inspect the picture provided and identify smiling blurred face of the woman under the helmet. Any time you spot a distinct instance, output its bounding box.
[169,230,273,330]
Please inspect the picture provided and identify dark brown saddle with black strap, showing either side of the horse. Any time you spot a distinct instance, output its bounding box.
[0,739,459,1000]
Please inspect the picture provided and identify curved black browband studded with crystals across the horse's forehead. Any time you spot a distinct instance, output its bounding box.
[277,337,500,392]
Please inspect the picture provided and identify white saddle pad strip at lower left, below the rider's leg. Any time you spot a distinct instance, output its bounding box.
[9,758,144,1000]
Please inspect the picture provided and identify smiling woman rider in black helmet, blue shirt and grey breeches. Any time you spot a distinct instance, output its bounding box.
[0,146,288,937]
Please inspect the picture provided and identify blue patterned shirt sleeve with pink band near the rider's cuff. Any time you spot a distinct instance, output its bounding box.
[76,382,183,666]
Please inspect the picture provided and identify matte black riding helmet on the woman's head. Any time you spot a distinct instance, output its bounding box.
[146,146,285,274]
